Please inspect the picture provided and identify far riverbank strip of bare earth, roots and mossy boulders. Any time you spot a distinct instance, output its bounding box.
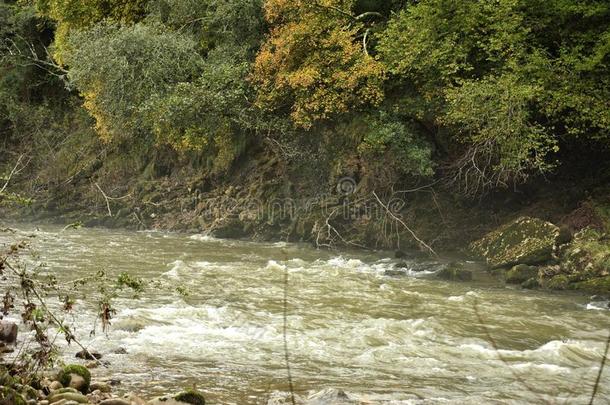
[6,166,610,294]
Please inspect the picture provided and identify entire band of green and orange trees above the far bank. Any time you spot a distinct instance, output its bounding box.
[0,0,610,196]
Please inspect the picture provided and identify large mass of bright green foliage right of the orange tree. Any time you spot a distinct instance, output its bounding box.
[377,0,610,194]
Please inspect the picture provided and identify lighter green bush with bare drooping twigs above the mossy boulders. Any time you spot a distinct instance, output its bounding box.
[443,74,558,189]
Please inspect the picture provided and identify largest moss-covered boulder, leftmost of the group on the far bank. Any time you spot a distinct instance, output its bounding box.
[470,217,560,268]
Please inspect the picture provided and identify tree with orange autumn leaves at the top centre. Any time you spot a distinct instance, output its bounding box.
[252,0,385,128]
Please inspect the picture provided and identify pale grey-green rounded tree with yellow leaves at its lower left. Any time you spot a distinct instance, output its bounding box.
[66,24,201,140]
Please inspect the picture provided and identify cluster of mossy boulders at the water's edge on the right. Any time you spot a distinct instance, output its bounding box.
[470,213,610,294]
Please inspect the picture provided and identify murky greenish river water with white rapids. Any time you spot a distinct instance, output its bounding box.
[0,225,610,404]
